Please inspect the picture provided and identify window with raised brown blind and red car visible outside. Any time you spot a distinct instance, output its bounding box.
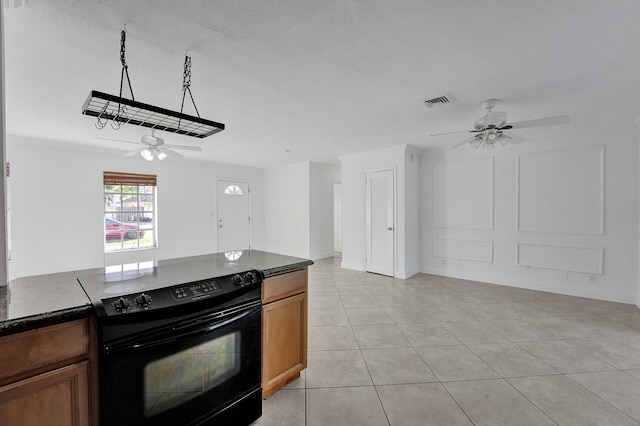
[104,172,157,253]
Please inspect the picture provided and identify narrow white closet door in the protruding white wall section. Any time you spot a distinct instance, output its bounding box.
[365,170,395,276]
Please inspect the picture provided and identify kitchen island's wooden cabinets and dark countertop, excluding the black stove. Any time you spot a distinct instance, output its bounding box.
[0,250,313,426]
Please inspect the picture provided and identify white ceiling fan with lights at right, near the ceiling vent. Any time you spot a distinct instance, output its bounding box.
[429,99,569,149]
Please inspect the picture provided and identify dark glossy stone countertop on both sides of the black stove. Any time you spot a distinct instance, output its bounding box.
[0,250,313,336]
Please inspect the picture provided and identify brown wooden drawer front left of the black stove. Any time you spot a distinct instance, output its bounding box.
[0,319,89,379]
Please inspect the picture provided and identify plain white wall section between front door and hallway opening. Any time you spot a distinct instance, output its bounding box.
[265,163,311,258]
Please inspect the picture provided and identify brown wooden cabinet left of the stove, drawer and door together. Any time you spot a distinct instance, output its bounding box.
[0,319,98,426]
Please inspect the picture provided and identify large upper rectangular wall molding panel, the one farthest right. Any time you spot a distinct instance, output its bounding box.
[517,146,605,235]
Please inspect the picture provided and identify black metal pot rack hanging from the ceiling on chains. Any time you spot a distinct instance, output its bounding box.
[82,29,225,138]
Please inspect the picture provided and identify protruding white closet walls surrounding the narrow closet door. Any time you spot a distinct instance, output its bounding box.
[341,145,419,278]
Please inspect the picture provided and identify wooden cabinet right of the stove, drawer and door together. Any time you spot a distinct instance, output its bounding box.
[262,268,308,398]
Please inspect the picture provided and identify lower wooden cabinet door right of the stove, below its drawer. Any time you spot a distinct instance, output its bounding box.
[262,293,307,398]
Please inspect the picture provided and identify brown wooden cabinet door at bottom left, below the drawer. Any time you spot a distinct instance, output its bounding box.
[0,361,90,426]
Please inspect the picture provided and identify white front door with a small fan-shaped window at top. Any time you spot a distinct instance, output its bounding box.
[217,180,251,252]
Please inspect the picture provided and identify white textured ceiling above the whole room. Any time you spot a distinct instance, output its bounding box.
[3,0,640,166]
